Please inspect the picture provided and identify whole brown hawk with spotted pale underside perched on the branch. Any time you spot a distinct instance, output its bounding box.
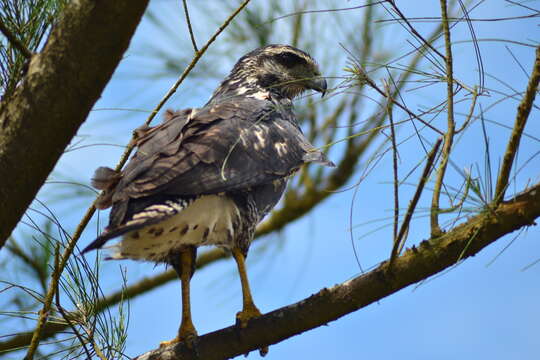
[83,45,333,345]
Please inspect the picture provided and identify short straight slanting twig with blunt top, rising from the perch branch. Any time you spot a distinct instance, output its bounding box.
[388,138,442,269]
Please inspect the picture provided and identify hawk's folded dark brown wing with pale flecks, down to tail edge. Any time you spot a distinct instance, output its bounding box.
[83,97,333,250]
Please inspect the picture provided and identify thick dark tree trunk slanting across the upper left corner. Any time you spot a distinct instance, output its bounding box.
[0,0,148,247]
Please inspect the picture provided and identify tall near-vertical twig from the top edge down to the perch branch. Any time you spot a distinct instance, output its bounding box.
[430,0,456,237]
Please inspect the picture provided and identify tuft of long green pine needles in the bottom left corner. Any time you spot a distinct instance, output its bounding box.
[0,217,129,359]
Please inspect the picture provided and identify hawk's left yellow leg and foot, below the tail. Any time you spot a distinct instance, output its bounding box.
[160,246,197,347]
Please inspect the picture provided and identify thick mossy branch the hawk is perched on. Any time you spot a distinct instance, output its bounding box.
[137,184,540,360]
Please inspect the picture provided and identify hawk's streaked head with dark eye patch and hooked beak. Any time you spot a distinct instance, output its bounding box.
[213,45,327,99]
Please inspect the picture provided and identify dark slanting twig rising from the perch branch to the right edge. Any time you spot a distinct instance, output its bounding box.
[494,46,540,204]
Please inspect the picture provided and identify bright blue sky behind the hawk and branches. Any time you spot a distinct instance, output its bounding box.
[2,1,540,360]
